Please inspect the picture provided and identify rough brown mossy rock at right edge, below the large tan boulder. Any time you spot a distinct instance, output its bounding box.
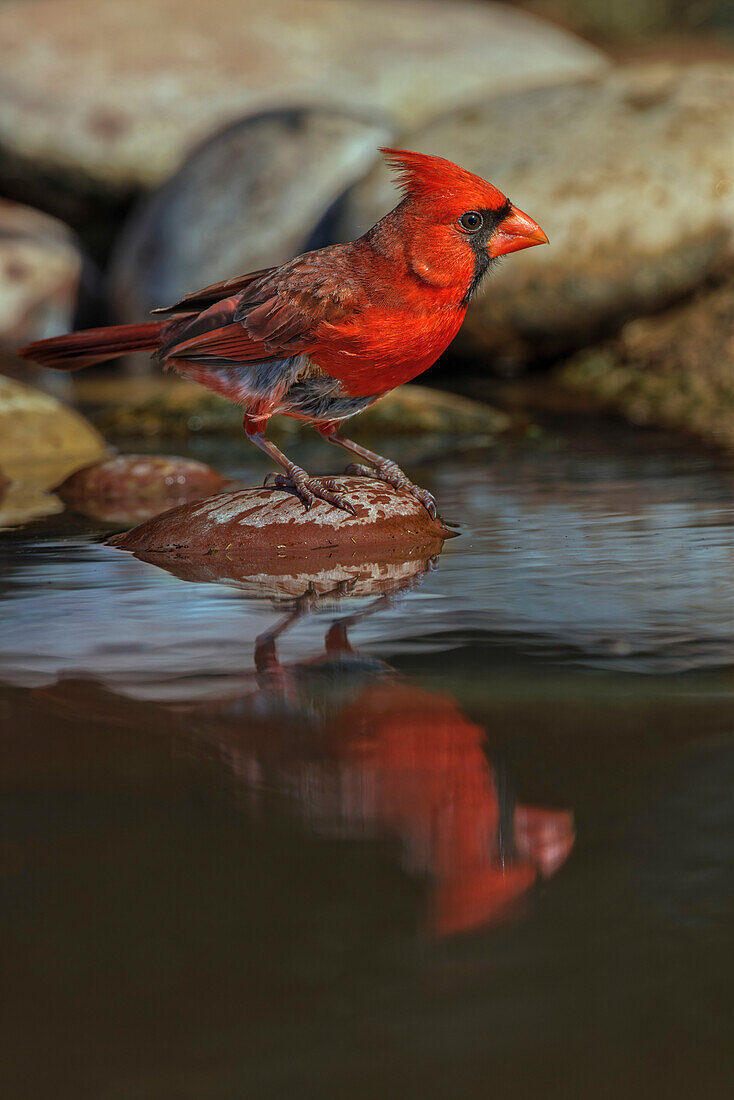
[557,278,734,450]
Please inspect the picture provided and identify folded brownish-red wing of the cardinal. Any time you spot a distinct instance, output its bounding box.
[160,245,361,363]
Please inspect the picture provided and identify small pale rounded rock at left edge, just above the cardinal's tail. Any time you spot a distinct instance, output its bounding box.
[0,199,81,351]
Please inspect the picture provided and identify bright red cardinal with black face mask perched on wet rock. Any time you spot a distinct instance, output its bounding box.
[19,149,548,516]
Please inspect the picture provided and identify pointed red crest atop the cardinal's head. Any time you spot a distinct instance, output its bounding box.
[380,147,507,209]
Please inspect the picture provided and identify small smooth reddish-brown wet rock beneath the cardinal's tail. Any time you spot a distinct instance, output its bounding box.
[56,454,224,524]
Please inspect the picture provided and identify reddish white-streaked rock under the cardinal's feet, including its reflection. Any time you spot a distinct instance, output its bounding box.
[110,477,454,595]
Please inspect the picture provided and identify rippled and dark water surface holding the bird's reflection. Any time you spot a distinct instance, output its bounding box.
[0,428,734,1100]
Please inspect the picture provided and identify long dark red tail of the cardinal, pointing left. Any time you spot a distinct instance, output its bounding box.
[18,321,166,371]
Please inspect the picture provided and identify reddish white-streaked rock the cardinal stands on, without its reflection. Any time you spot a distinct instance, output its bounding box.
[111,476,452,573]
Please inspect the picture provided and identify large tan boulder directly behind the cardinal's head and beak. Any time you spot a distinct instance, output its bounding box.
[339,63,734,366]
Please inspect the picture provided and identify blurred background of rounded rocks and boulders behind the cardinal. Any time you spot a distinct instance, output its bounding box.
[0,0,734,492]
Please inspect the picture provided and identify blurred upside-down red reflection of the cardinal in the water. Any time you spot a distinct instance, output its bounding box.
[205,600,574,935]
